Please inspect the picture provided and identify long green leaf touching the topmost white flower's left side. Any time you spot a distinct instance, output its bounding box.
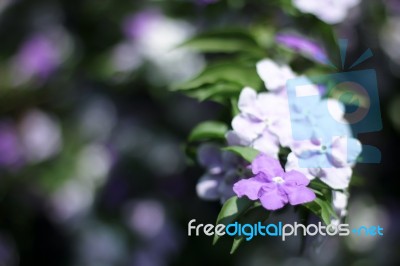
[172,61,262,91]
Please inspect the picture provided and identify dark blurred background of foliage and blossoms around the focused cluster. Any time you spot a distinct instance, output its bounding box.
[0,0,400,266]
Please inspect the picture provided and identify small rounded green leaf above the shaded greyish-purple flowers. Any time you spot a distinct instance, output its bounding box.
[189,121,228,141]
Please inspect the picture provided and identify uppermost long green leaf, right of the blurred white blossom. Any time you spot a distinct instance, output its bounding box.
[181,30,264,54]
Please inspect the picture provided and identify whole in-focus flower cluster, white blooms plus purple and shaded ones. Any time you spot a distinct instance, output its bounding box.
[198,59,361,210]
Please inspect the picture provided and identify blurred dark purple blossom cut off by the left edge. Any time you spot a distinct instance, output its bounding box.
[0,122,23,166]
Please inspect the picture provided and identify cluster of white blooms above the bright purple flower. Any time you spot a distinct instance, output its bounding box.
[227,59,361,192]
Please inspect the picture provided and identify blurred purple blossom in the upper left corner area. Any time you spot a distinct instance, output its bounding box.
[15,33,61,80]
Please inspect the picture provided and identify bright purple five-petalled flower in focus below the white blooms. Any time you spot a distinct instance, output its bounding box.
[233,154,315,210]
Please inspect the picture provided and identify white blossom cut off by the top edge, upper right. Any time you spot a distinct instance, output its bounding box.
[293,0,360,24]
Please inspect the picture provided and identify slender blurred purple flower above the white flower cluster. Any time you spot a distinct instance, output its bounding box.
[275,33,328,64]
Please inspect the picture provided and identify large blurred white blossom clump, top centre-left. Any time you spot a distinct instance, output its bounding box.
[110,10,204,85]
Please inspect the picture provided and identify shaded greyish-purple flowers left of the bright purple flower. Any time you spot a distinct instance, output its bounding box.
[196,144,243,202]
